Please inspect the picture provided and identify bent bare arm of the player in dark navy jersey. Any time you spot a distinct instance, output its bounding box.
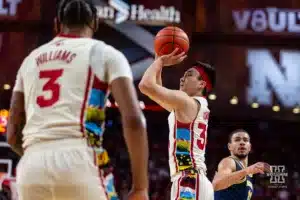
[212,158,248,191]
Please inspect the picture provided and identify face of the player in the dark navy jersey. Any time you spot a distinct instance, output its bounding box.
[228,132,251,159]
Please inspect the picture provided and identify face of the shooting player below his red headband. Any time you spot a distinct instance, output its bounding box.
[180,68,205,96]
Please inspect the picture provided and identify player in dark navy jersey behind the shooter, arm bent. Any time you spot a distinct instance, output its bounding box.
[213,130,270,200]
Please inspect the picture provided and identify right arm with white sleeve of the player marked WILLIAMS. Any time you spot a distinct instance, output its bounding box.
[96,47,149,194]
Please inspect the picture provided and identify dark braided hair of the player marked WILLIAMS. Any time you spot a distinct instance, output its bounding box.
[57,0,97,31]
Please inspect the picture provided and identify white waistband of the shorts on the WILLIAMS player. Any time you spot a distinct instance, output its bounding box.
[25,138,88,152]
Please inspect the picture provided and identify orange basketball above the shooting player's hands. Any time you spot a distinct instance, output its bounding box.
[154,26,190,56]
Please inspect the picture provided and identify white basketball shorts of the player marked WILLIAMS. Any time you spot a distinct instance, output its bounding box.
[17,138,107,200]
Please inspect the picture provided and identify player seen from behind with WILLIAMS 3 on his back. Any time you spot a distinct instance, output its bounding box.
[7,0,148,200]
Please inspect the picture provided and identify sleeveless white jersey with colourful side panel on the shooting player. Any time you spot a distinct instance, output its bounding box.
[168,97,210,177]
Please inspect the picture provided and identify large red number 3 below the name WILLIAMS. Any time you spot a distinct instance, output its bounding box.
[36,69,63,108]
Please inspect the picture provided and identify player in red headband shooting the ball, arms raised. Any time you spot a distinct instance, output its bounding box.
[139,50,215,200]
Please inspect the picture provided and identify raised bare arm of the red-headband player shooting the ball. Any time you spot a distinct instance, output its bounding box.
[139,51,190,112]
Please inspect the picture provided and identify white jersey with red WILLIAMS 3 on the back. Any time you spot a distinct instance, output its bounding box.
[14,35,132,148]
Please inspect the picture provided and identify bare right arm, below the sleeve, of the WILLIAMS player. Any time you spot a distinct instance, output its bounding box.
[111,78,148,189]
